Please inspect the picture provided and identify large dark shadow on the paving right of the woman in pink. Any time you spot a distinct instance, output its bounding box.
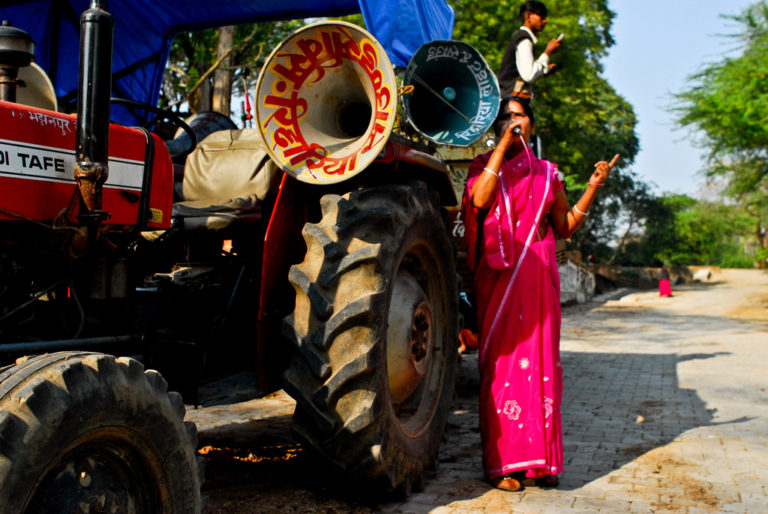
[561,352,745,490]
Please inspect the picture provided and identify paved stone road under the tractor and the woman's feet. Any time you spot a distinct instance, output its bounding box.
[190,270,768,513]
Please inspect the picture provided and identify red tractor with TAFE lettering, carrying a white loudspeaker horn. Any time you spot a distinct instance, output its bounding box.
[0,0,496,506]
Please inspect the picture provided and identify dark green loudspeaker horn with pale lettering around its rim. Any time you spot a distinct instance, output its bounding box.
[403,41,501,146]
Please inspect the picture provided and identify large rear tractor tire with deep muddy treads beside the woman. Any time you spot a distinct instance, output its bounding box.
[284,182,458,495]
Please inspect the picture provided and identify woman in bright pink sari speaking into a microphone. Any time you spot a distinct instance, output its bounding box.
[463,99,619,491]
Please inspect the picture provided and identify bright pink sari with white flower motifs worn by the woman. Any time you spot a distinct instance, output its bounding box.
[464,146,563,478]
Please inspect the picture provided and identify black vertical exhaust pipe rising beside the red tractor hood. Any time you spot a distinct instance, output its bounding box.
[75,0,114,218]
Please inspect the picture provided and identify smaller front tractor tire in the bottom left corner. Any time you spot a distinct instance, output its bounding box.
[0,352,202,514]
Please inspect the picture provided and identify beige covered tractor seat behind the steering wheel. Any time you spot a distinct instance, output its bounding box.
[172,129,279,230]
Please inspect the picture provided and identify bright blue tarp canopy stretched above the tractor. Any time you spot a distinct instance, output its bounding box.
[0,0,454,124]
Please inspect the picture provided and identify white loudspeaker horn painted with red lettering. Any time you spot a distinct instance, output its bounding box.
[256,21,397,184]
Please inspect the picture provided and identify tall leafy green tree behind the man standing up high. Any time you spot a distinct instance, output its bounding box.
[452,0,649,260]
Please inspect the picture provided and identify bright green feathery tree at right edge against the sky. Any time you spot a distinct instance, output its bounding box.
[675,1,768,268]
